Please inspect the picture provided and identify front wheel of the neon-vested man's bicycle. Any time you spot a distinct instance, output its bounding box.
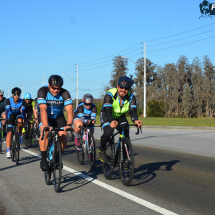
[118,138,134,186]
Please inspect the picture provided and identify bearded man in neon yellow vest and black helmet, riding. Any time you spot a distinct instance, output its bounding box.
[99,76,142,163]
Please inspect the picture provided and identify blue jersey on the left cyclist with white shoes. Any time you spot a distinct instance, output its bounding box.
[6,97,26,119]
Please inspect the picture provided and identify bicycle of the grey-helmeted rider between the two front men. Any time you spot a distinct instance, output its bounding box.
[76,124,101,169]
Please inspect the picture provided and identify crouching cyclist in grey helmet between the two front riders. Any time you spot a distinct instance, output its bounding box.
[73,94,97,155]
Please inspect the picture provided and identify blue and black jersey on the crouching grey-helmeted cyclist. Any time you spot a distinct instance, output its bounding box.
[74,102,97,122]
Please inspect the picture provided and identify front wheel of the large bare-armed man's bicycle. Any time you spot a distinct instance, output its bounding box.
[53,141,62,193]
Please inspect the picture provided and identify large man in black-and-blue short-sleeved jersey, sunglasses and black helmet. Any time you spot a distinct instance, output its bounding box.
[37,75,73,171]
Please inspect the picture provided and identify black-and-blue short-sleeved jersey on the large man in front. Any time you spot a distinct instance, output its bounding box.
[37,87,73,119]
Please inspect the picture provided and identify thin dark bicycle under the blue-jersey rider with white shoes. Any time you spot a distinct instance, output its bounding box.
[10,121,20,165]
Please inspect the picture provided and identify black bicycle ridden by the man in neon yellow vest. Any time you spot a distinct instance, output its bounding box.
[102,122,142,186]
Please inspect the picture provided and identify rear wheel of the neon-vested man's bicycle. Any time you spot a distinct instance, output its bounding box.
[102,142,115,180]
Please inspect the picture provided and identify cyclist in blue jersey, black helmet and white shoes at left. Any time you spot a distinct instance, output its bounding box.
[6,87,26,158]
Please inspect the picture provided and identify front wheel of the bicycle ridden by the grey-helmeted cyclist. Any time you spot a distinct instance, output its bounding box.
[87,133,96,169]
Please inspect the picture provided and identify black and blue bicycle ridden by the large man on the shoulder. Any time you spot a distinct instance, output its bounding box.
[41,128,70,193]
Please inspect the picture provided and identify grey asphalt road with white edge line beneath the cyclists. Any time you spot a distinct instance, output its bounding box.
[0,129,215,215]
